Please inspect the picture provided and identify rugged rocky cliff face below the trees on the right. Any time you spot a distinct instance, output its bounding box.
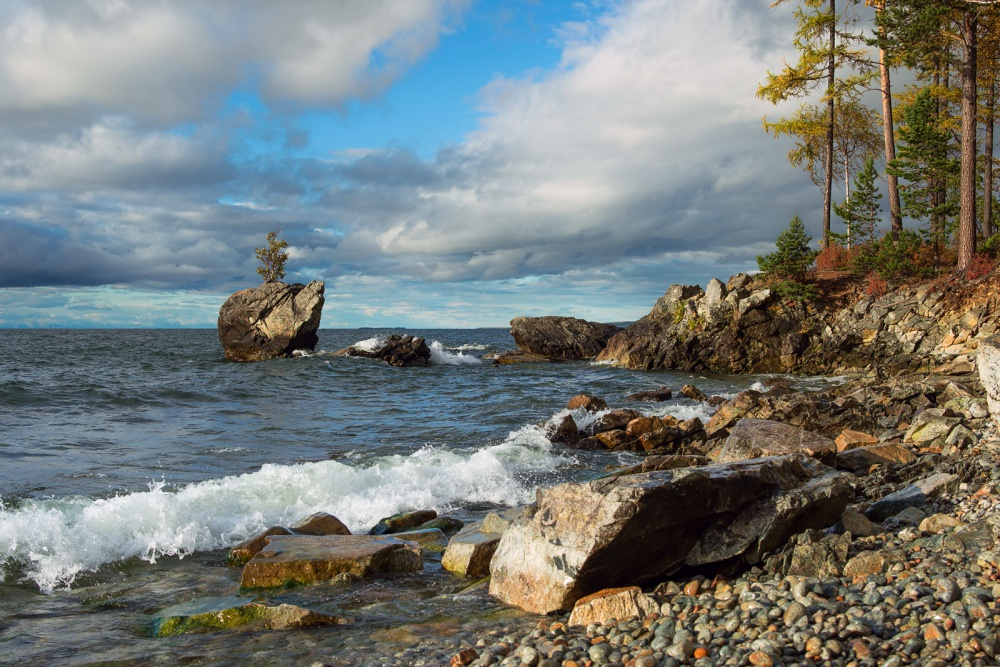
[598,273,1000,373]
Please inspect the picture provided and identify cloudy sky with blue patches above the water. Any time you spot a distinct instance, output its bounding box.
[0,0,822,328]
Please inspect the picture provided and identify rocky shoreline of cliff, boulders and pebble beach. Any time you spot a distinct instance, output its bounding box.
[201,276,1000,667]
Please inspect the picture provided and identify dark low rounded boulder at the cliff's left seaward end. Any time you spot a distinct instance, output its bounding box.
[510,316,621,360]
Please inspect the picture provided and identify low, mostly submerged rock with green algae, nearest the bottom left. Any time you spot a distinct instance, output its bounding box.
[153,596,350,637]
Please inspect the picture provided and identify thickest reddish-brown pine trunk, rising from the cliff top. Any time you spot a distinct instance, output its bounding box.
[955,10,979,274]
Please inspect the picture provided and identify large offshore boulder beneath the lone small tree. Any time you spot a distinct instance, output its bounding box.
[219,281,324,361]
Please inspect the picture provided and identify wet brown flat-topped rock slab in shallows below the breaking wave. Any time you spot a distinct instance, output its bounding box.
[247,535,424,588]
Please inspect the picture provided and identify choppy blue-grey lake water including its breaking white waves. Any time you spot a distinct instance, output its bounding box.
[0,329,757,665]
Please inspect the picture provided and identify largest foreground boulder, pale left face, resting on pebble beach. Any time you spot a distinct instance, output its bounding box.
[490,455,853,614]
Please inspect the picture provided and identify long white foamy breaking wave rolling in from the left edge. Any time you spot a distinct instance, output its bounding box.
[0,434,570,592]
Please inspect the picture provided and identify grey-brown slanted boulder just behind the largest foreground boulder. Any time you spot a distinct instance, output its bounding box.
[718,419,837,466]
